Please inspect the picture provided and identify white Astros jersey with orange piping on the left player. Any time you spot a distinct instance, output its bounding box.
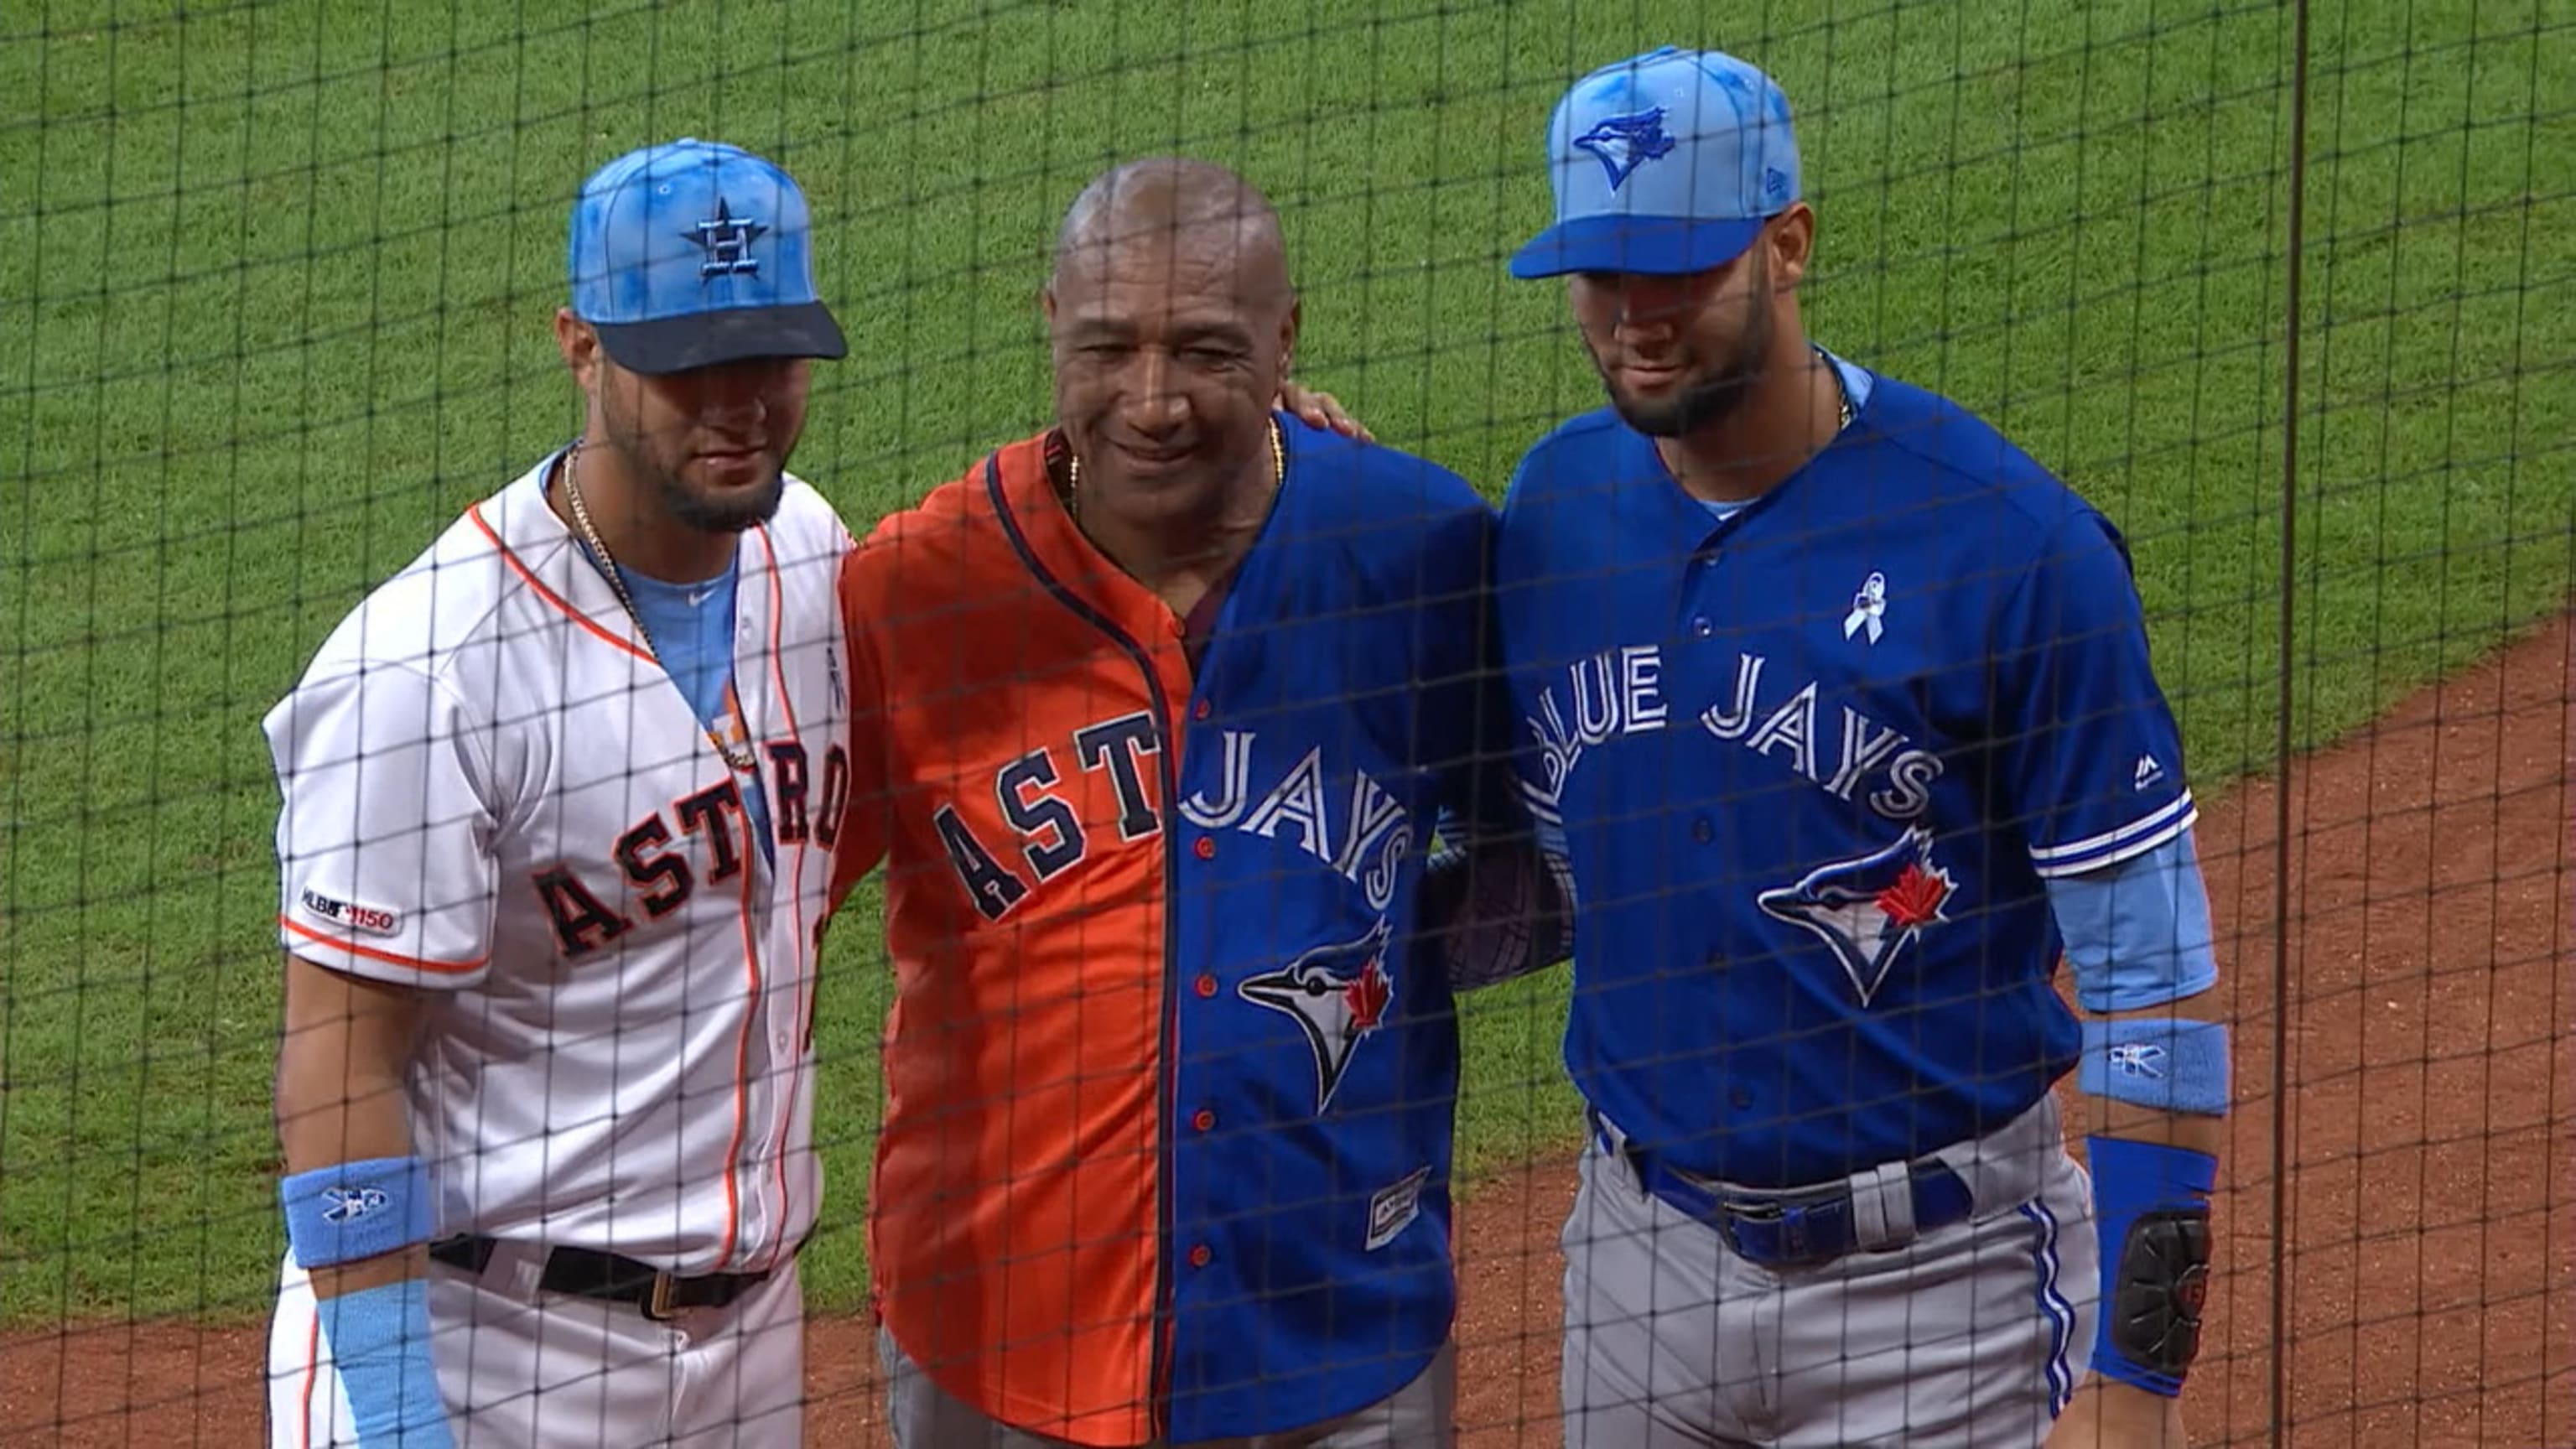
[265,456,850,1274]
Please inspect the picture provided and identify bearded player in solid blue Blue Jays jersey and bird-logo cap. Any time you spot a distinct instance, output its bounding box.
[1494,46,2228,1449]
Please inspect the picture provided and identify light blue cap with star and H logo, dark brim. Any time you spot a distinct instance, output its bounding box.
[569,137,850,374]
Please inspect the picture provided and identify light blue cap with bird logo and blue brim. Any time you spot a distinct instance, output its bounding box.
[1512,46,1798,278]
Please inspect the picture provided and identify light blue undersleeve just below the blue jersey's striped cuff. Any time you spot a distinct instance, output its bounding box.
[2048,830,2218,1013]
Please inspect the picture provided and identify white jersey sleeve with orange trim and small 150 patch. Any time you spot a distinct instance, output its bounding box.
[265,657,500,990]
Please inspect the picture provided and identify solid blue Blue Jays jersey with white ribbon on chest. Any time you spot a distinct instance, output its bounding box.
[1494,364,2194,1186]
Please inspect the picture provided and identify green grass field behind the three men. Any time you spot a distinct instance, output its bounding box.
[0,0,2576,1325]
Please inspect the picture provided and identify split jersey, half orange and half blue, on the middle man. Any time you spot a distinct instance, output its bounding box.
[839,418,1492,1444]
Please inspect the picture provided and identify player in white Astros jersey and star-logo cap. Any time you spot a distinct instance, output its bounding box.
[265,139,850,1449]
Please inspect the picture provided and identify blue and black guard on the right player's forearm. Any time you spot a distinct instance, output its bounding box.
[2084,1137,2218,1398]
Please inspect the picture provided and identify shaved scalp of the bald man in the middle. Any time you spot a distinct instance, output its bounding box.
[1051,158,1291,314]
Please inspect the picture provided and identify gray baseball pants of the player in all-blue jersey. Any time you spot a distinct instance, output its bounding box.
[1564,1096,2100,1449]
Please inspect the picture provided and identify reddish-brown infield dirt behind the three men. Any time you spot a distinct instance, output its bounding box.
[0,619,2576,1449]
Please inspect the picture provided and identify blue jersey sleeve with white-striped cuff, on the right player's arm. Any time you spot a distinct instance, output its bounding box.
[1994,508,2194,876]
